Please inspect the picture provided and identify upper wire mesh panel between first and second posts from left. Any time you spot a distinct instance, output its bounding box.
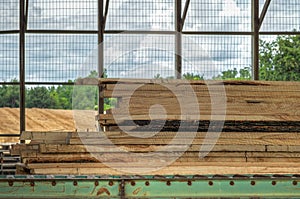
[28,0,97,30]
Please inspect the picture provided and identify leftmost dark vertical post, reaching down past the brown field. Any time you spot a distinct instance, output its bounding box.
[19,0,26,139]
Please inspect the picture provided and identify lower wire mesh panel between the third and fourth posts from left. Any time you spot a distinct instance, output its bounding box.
[183,35,252,79]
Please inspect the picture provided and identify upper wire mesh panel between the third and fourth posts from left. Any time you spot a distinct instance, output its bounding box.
[183,0,252,31]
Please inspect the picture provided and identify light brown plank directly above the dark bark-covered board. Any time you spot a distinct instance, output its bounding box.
[109,105,300,121]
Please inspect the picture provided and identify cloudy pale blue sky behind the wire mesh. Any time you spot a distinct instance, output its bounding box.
[0,0,300,82]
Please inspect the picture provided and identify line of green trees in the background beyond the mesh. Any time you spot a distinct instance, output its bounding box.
[0,35,300,110]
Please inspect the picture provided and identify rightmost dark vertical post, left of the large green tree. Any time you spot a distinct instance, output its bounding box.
[252,0,259,80]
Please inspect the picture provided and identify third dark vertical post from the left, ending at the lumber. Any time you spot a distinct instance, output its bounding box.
[175,0,182,79]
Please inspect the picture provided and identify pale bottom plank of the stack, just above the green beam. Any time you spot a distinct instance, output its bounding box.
[32,163,300,175]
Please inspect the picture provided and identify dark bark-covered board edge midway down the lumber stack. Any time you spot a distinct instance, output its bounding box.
[103,120,300,132]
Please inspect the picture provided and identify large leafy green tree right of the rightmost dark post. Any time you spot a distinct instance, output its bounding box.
[260,35,300,81]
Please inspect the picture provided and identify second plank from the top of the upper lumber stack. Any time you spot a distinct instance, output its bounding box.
[101,87,300,97]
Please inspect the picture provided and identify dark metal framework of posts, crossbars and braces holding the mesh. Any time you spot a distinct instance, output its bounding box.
[0,0,300,136]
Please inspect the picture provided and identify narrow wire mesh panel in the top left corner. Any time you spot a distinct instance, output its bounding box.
[0,0,20,31]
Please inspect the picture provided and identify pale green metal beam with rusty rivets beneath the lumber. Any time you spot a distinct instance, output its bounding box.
[0,175,300,199]
